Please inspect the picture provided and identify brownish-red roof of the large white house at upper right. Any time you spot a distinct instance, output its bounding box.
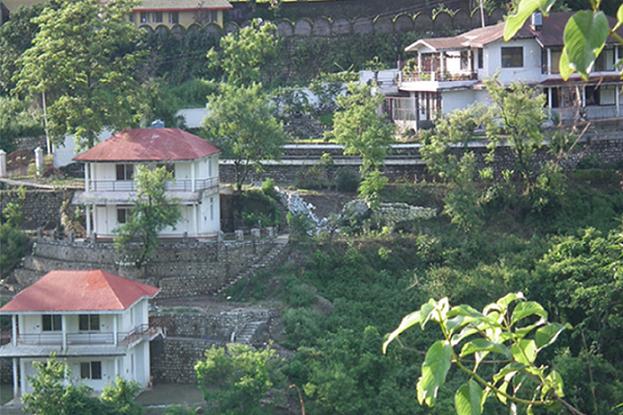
[405,12,623,52]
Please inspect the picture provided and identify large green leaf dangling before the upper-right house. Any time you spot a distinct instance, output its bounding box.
[560,10,610,79]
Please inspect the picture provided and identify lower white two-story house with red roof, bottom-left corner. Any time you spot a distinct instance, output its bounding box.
[0,270,162,397]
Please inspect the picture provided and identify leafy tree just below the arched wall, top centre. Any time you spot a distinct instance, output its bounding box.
[207,19,278,85]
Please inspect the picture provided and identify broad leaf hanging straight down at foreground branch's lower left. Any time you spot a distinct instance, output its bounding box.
[417,340,452,406]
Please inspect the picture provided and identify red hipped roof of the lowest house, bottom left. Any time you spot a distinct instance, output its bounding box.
[0,269,160,313]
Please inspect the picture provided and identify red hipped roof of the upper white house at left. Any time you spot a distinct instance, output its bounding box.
[74,128,220,161]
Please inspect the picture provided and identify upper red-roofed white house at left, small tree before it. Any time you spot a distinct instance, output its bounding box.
[73,128,220,238]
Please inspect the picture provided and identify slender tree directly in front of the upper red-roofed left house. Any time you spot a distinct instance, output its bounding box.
[115,166,181,268]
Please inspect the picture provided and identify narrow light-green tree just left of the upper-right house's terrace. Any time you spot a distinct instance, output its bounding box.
[331,82,394,202]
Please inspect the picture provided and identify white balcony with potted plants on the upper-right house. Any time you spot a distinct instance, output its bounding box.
[398,71,478,91]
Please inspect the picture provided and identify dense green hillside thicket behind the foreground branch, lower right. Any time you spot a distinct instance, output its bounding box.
[224,170,623,415]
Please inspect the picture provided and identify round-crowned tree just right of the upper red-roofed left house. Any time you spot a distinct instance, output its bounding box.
[205,83,285,192]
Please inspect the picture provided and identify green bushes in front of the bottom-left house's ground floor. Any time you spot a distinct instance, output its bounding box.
[22,357,143,415]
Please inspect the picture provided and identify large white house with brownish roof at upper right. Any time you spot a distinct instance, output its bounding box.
[386,12,623,131]
